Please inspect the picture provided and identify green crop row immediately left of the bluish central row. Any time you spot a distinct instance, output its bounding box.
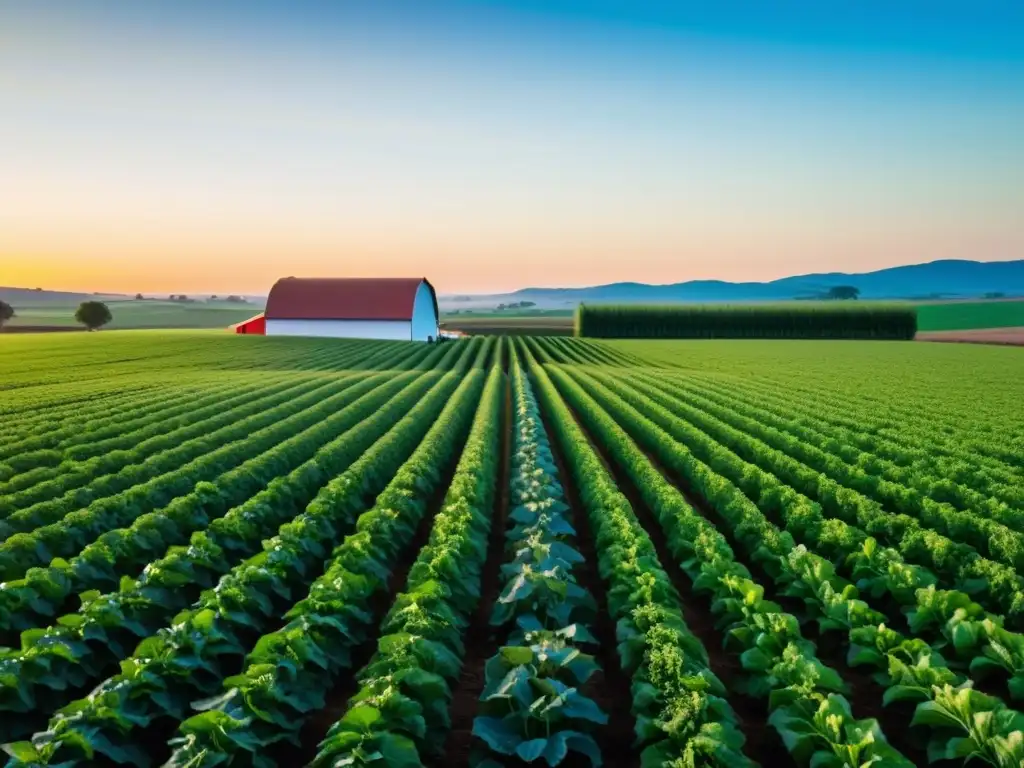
[313,367,505,768]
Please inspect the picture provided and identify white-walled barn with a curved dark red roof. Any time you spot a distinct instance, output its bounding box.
[263,278,437,341]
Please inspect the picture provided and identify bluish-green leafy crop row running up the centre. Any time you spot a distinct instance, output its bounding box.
[470,354,608,766]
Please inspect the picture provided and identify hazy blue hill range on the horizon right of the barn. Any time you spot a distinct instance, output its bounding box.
[440,260,1024,309]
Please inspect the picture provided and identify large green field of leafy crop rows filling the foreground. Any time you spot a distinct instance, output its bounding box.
[0,331,1024,768]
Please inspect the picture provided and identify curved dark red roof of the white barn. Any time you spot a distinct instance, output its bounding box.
[265,278,437,321]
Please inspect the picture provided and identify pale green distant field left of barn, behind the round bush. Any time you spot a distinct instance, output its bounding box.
[6,299,262,329]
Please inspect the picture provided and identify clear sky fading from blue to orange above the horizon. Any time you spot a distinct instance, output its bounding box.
[0,0,1024,294]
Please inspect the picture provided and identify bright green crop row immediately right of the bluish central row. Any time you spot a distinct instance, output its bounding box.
[516,349,752,766]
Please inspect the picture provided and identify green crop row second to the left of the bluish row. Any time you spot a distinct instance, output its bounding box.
[162,369,485,767]
